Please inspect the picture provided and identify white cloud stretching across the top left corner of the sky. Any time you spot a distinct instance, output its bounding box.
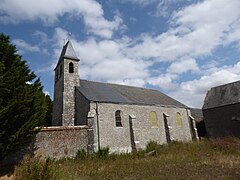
[0,0,122,38]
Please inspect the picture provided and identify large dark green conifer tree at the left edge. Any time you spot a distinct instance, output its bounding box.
[0,34,48,160]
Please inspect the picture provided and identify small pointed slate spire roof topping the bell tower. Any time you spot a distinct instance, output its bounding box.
[54,41,80,70]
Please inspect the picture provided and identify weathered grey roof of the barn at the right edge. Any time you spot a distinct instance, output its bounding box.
[203,81,240,109]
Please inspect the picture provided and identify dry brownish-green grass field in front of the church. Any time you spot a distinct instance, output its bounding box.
[14,138,240,180]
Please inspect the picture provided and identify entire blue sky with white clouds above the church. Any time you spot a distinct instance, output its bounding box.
[0,0,240,108]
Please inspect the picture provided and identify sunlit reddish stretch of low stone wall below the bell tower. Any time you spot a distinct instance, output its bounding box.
[34,126,89,159]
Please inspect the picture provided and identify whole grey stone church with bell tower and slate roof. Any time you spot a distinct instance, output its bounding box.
[52,41,197,153]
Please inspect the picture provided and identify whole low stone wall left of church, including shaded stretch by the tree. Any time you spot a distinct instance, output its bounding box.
[0,126,90,169]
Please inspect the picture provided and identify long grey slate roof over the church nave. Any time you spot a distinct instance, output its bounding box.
[77,80,187,108]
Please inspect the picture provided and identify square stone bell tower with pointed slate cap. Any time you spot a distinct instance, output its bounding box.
[52,41,80,126]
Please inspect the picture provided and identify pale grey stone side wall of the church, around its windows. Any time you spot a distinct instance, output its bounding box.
[91,103,191,152]
